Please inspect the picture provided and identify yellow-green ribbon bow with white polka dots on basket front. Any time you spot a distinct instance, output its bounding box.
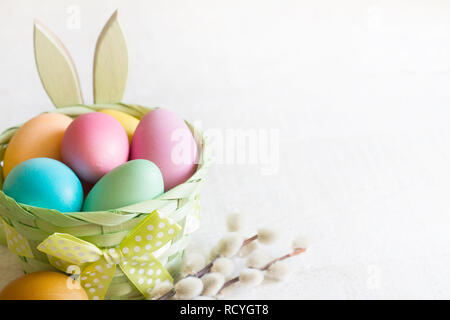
[38,211,181,300]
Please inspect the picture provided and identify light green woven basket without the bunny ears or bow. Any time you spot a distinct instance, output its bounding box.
[0,104,209,299]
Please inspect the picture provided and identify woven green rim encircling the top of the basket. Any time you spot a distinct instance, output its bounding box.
[0,102,211,226]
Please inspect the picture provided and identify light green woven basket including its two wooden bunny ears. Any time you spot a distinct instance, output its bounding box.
[0,12,210,299]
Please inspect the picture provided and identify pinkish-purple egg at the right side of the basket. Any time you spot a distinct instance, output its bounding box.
[130,109,198,191]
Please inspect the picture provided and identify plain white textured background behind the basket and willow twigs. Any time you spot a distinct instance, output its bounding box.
[0,0,450,299]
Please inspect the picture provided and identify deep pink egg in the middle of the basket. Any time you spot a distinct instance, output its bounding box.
[61,112,129,183]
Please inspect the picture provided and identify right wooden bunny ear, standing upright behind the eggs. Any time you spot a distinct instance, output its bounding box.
[94,11,128,104]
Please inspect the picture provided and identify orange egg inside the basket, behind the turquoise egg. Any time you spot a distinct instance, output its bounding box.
[3,113,72,177]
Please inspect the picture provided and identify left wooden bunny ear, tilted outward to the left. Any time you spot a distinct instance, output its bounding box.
[34,21,83,107]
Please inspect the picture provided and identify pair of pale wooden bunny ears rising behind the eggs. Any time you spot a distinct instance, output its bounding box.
[34,11,128,107]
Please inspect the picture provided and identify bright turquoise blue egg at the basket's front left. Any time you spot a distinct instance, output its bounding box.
[3,158,83,212]
